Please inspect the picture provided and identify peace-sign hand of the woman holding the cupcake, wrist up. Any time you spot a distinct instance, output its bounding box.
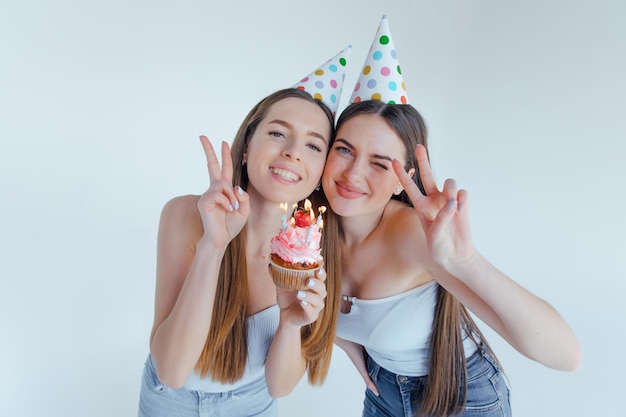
[198,136,250,248]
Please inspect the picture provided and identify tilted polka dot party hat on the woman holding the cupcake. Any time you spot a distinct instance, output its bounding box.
[292,45,352,115]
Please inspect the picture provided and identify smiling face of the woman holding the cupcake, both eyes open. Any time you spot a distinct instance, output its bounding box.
[244,97,331,202]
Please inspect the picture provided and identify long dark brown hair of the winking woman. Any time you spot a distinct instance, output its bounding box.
[337,100,495,417]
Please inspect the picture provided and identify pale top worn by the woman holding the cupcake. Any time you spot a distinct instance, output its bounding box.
[184,304,280,393]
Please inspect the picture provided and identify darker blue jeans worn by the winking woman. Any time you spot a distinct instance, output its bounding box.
[363,348,511,417]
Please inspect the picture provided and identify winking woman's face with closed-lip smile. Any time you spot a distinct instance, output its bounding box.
[322,114,406,217]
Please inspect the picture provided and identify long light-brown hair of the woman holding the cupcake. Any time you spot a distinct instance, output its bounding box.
[195,88,341,384]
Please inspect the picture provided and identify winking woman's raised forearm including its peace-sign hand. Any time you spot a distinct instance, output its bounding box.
[393,145,580,370]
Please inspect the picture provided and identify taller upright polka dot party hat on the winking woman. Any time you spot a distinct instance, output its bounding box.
[350,16,409,104]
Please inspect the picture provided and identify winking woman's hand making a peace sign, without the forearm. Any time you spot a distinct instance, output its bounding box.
[393,145,475,272]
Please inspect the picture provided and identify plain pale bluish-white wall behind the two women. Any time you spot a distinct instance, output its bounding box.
[0,0,626,417]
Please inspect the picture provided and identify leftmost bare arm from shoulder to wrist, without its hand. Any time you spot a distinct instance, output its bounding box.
[150,196,224,388]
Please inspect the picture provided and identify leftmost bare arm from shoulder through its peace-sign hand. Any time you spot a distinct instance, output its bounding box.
[150,136,250,387]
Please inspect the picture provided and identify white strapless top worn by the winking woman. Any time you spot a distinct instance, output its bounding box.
[337,281,476,376]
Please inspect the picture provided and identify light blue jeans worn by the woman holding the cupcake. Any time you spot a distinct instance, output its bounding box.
[137,357,278,417]
